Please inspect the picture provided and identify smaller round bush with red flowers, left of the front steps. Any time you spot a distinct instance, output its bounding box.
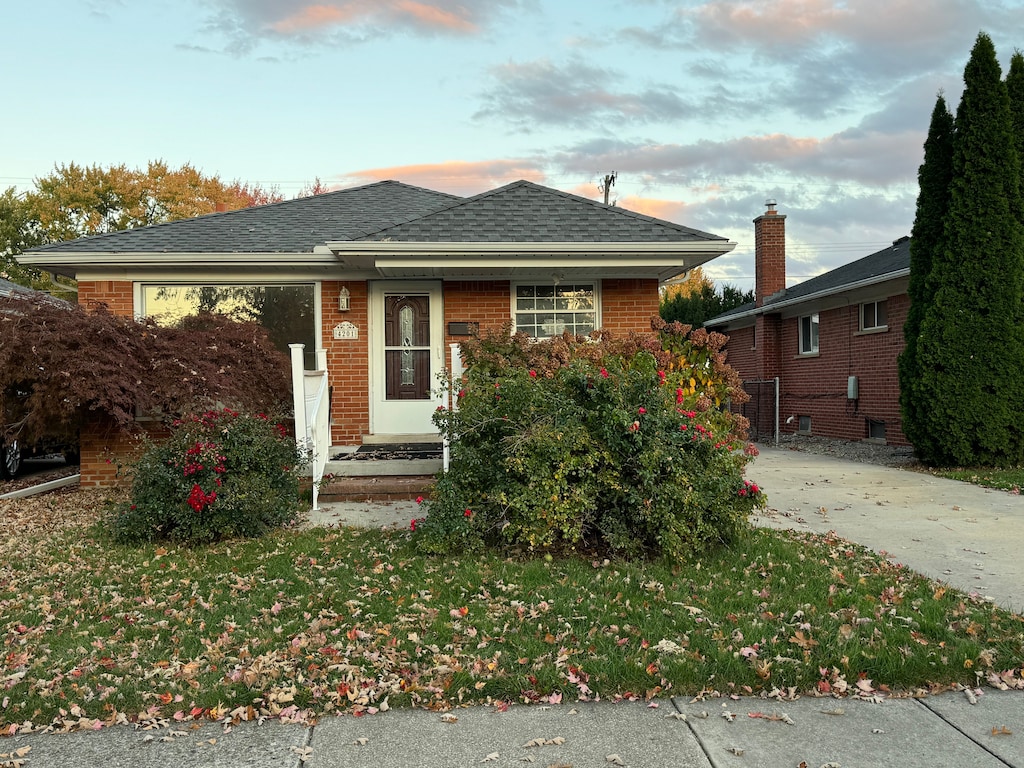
[111,409,302,544]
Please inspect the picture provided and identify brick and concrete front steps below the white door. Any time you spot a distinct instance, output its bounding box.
[319,454,441,502]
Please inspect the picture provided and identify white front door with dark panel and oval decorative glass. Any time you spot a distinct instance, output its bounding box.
[370,281,444,435]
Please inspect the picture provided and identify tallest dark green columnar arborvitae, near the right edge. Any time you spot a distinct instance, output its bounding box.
[915,33,1024,466]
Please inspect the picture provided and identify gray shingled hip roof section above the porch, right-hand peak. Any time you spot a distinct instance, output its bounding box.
[358,180,726,243]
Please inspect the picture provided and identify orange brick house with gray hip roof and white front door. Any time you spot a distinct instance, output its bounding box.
[19,181,735,485]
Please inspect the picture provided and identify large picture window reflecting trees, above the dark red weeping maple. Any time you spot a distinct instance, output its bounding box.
[139,284,317,370]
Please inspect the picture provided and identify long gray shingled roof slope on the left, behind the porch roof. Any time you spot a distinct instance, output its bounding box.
[25,181,462,253]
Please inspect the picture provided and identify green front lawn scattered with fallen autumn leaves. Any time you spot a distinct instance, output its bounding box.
[0,495,1024,733]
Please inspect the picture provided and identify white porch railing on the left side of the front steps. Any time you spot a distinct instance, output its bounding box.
[288,344,331,510]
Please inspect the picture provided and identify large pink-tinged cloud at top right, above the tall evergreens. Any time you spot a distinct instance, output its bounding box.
[617,0,1020,120]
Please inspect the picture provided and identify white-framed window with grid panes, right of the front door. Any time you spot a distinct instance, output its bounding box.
[513,283,597,339]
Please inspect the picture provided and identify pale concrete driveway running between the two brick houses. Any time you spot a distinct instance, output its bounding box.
[746,447,1024,613]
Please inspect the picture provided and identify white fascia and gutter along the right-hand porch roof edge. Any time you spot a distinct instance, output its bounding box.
[327,240,736,259]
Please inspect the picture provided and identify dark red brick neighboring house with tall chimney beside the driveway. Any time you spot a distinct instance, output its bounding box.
[705,201,910,445]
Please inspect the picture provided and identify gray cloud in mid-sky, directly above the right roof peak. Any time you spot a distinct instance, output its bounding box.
[474,58,696,130]
